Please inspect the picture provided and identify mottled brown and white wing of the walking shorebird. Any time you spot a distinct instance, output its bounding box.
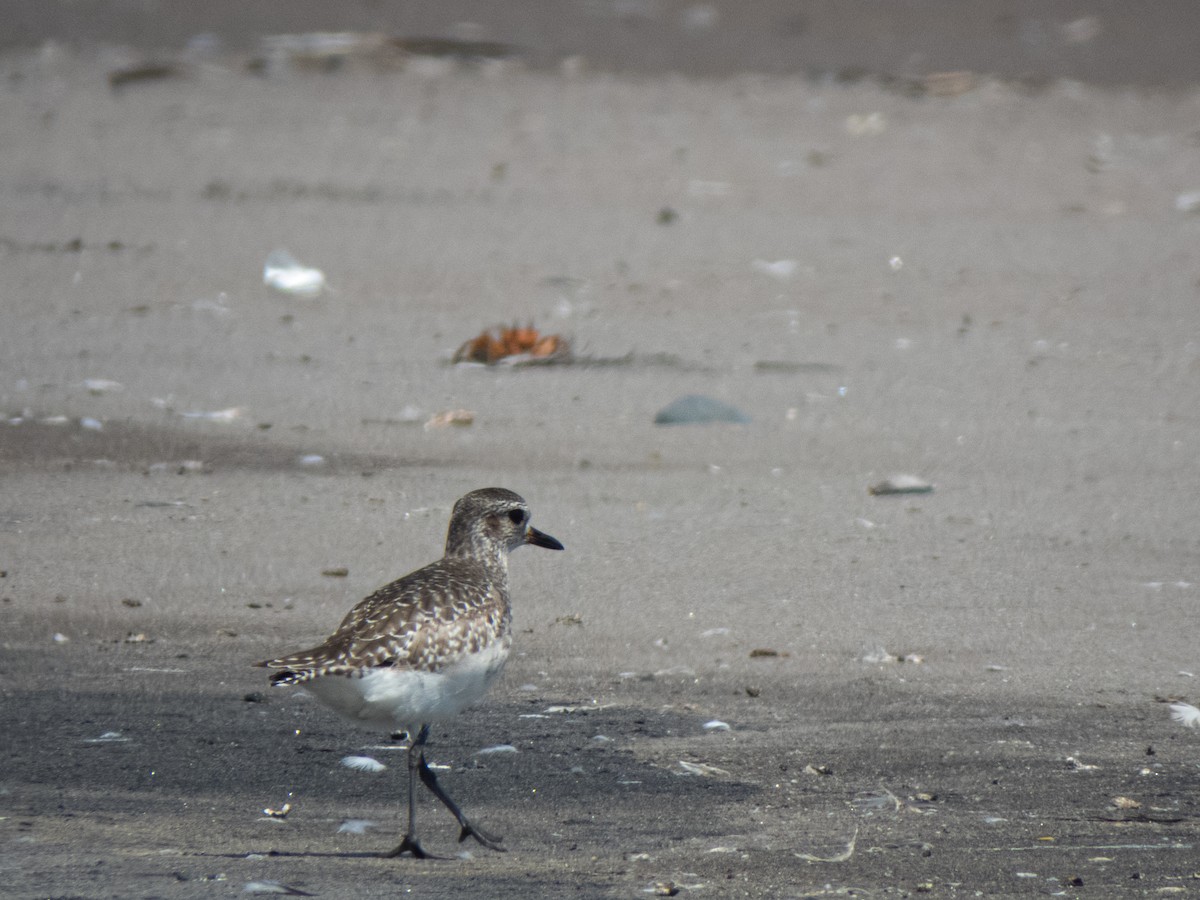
[259,559,509,684]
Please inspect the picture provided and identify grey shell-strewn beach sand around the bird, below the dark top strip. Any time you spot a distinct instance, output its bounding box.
[0,7,1200,898]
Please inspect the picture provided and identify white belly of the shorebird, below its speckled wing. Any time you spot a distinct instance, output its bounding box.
[305,641,509,731]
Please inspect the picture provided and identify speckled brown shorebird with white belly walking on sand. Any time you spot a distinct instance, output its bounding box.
[254,487,563,859]
